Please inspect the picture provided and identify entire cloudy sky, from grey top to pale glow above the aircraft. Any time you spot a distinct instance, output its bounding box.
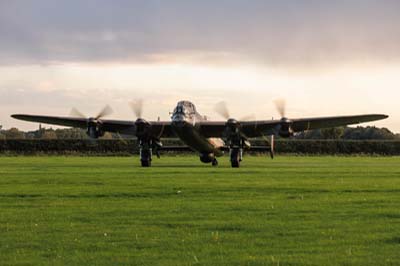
[0,0,400,132]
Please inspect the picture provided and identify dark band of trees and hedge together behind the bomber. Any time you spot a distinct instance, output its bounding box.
[0,124,400,155]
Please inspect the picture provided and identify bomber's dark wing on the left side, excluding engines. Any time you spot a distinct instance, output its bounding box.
[11,114,175,137]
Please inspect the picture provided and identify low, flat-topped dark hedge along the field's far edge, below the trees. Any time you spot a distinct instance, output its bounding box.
[0,140,400,155]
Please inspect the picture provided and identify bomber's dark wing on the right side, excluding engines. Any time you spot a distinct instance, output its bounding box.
[199,114,388,138]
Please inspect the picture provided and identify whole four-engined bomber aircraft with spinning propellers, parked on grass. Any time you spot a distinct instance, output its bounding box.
[11,101,388,167]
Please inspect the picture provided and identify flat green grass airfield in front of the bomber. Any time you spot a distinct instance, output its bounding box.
[0,156,400,265]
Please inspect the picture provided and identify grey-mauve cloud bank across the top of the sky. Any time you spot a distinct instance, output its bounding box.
[0,0,400,64]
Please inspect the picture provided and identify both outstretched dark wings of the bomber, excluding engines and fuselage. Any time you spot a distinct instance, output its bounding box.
[11,114,388,138]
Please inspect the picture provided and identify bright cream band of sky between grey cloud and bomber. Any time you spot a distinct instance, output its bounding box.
[0,61,400,130]
